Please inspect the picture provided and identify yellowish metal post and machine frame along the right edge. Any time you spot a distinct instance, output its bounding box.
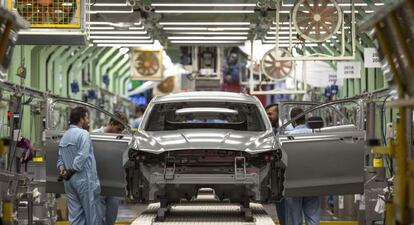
[373,0,414,222]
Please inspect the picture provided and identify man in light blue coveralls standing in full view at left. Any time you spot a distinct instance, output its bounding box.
[57,107,101,225]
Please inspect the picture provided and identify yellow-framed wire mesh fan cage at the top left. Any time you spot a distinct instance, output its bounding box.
[8,0,82,29]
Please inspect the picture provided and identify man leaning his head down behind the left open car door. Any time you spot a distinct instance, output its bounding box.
[92,112,128,225]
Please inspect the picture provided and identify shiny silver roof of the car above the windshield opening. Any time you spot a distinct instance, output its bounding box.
[154,91,258,103]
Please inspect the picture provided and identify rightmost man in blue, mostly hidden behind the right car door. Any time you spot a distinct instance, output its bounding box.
[285,108,321,225]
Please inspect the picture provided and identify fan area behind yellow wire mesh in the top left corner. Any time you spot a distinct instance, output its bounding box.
[15,0,78,25]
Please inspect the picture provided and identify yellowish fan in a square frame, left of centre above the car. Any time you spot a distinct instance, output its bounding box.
[132,49,162,80]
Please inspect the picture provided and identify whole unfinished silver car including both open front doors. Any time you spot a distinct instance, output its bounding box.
[46,92,365,202]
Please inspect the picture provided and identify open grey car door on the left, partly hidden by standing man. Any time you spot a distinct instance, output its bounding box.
[45,130,131,196]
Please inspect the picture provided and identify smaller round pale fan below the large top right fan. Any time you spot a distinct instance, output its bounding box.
[261,48,293,80]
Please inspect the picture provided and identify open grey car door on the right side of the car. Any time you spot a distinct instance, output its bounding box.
[280,129,365,197]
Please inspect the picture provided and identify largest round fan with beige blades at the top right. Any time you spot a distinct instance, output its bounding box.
[292,0,342,42]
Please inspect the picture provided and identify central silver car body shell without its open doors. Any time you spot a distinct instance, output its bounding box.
[124,92,286,202]
